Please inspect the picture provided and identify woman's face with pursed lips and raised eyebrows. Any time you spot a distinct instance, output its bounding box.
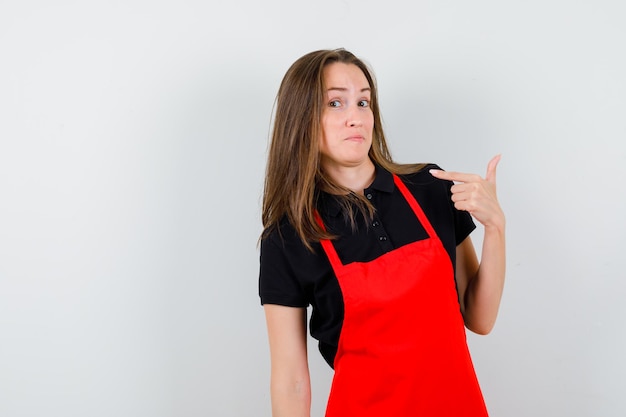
[320,62,374,169]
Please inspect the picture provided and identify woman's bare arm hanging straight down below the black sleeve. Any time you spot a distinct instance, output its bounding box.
[264,304,311,417]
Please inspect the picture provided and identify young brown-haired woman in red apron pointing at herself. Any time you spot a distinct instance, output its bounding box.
[259,49,505,417]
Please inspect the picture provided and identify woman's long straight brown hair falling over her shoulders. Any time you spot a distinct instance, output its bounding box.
[261,49,424,250]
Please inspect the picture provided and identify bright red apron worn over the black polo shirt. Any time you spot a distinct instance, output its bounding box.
[318,175,487,417]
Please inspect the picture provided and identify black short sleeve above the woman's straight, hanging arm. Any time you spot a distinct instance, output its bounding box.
[259,233,308,307]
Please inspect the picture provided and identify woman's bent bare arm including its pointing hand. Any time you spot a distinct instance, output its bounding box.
[431,155,506,334]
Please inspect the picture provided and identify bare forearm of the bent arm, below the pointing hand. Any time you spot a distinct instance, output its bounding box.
[465,221,506,334]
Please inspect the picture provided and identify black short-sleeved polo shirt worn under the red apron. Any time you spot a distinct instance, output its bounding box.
[259,165,476,366]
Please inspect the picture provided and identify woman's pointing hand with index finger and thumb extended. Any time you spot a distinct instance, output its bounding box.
[430,155,505,229]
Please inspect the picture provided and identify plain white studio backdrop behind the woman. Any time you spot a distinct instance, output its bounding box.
[0,0,626,417]
